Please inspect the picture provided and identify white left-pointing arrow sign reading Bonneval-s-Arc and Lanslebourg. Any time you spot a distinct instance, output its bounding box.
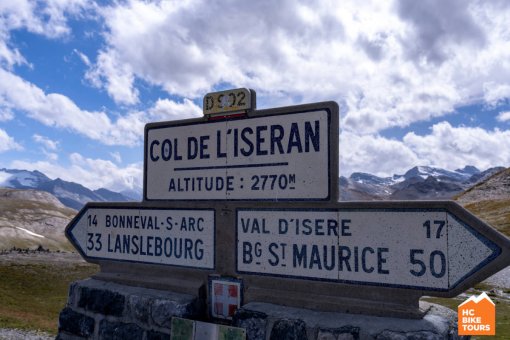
[66,206,215,269]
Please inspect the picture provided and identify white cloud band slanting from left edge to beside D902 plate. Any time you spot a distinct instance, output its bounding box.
[0,68,201,146]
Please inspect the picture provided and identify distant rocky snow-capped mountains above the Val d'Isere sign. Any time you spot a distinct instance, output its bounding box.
[340,165,504,201]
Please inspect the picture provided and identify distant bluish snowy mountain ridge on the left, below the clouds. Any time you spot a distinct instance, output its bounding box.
[0,169,137,210]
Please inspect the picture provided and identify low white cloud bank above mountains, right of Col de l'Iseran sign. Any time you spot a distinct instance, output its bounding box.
[339,122,510,176]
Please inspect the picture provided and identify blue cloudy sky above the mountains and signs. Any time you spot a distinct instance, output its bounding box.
[0,0,510,191]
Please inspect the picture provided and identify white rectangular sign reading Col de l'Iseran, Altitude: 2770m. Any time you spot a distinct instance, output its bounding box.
[145,109,337,200]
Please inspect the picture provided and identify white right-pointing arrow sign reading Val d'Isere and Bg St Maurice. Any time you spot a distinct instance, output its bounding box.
[236,209,501,291]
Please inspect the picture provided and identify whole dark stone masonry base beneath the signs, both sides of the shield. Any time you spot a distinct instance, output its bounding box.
[57,279,465,340]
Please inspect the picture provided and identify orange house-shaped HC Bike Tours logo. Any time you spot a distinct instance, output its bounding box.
[457,292,496,335]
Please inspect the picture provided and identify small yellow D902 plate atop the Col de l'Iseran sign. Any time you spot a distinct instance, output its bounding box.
[204,88,255,116]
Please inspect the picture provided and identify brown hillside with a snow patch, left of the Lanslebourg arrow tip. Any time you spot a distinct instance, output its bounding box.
[0,188,76,251]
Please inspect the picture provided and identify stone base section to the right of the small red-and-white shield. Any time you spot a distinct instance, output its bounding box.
[233,302,467,340]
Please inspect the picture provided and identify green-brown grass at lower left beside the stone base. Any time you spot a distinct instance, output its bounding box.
[0,263,98,334]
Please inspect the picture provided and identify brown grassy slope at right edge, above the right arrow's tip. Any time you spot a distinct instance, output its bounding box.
[455,168,510,236]
